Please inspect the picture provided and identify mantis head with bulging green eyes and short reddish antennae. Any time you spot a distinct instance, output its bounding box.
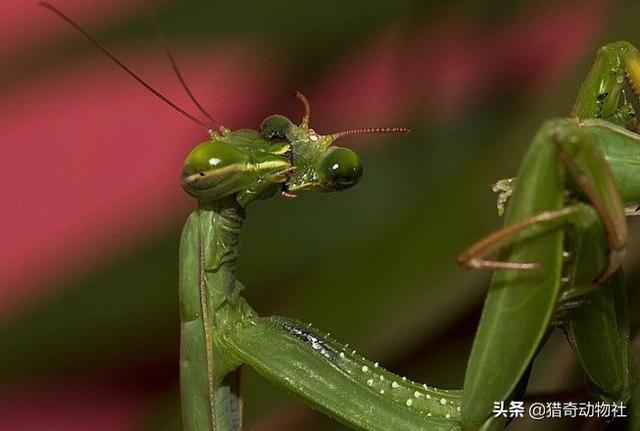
[181,94,408,206]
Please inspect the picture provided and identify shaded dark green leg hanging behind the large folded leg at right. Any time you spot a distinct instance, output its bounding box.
[557,199,631,403]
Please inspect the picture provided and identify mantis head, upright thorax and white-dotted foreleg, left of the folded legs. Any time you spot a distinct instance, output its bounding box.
[180,101,468,430]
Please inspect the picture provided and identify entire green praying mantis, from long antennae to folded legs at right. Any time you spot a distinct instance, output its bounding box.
[41,3,640,431]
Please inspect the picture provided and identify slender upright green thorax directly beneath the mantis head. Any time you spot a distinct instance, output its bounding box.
[180,201,245,431]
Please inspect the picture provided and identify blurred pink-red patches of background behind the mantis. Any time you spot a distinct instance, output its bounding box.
[0,1,613,431]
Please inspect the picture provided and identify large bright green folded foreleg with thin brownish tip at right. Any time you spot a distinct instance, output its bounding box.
[462,120,626,430]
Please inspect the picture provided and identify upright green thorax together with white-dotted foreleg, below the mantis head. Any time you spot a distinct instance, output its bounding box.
[180,199,461,431]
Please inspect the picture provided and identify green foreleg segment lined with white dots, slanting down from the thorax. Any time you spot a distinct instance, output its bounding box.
[217,317,461,431]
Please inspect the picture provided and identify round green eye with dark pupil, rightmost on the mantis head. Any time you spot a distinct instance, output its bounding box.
[319,147,362,190]
